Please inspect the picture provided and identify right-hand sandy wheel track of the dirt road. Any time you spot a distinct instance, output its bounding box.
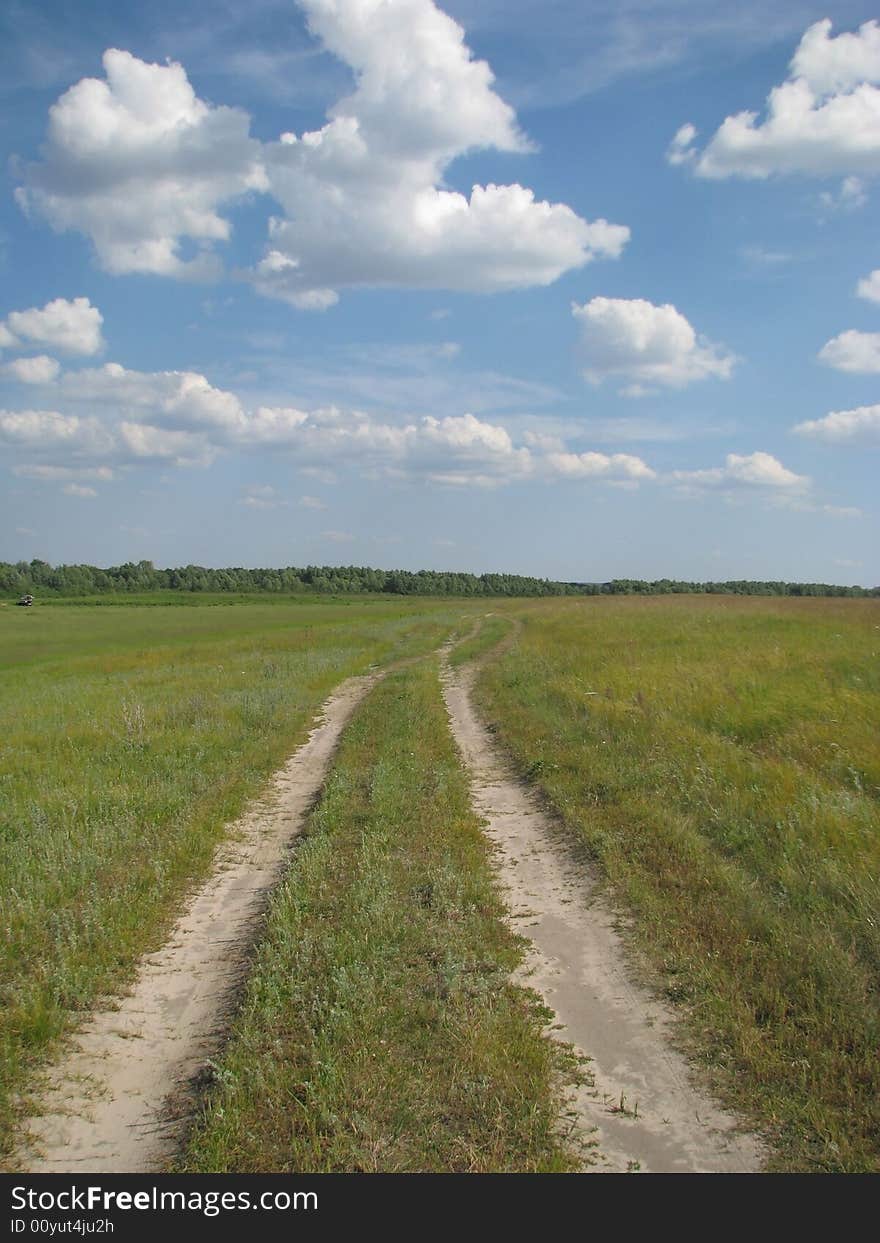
[442,635,763,1173]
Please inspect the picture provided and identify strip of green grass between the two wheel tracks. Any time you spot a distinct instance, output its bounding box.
[183,663,577,1172]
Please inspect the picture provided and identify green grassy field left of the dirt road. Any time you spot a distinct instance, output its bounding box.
[0,597,470,1152]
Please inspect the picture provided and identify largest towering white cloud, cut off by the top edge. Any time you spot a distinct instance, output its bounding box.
[252,0,629,310]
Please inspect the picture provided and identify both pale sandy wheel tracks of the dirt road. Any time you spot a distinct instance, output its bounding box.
[12,631,761,1172]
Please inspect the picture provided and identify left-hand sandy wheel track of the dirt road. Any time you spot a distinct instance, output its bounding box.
[19,672,383,1173]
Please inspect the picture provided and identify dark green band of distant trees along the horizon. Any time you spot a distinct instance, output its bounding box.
[0,561,880,597]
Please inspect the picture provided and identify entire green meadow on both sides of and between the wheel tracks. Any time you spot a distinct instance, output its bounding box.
[0,593,880,1171]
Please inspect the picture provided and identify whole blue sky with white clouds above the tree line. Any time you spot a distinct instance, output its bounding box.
[0,0,880,585]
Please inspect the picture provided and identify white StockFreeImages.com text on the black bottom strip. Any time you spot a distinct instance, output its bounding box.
[11,1183,318,1234]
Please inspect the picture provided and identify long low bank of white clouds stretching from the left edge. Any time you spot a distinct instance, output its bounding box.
[0,353,655,487]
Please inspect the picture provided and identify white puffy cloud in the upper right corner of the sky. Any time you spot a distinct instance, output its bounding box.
[667,19,880,179]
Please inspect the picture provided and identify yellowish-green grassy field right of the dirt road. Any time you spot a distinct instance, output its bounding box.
[477,597,880,1171]
